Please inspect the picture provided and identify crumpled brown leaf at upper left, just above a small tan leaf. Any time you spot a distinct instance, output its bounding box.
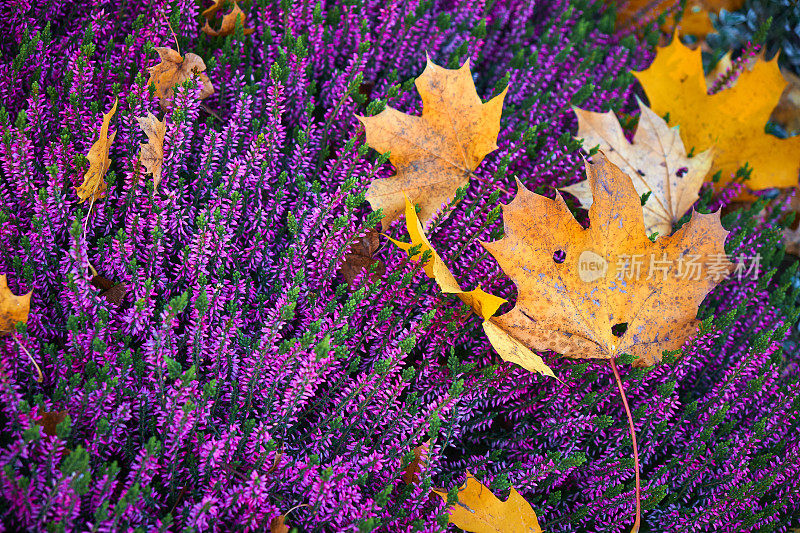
[147,47,214,110]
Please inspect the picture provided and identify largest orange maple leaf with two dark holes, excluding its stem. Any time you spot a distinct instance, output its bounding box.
[484,153,733,366]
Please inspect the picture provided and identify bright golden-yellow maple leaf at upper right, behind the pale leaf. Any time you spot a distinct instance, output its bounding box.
[633,39,800,190]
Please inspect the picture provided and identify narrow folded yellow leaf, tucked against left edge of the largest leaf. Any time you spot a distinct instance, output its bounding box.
[390,198,558,379]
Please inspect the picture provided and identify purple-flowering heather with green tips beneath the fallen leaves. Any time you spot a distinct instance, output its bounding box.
[0,0,800,532]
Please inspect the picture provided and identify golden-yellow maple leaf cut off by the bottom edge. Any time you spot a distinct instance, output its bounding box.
[433,472,542,533]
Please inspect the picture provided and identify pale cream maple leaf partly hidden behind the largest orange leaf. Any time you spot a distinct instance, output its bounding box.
[562,101,713,235]
